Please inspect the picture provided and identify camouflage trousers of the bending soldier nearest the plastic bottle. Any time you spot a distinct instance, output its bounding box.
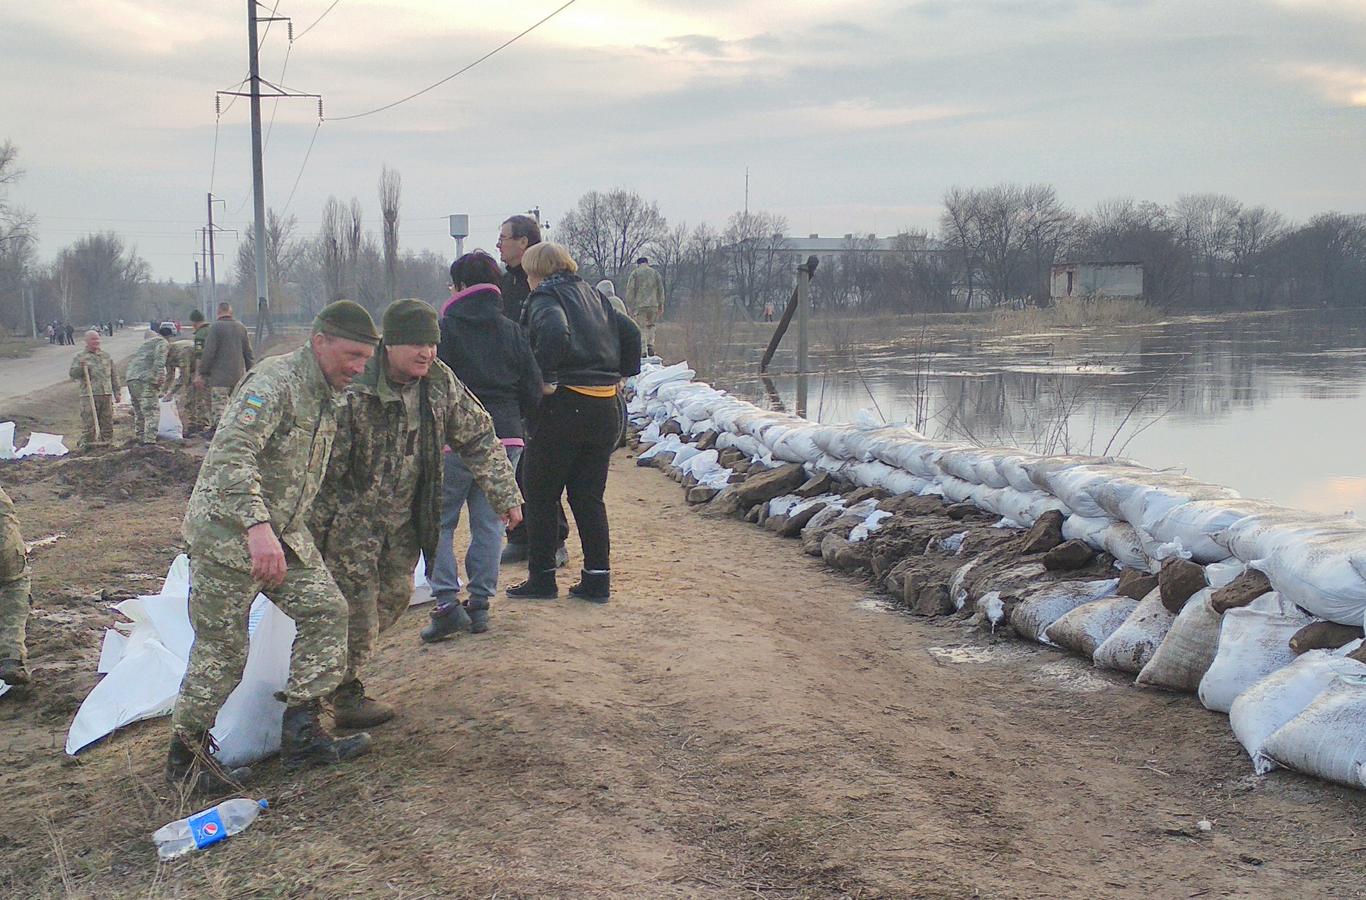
[171,549,347,731]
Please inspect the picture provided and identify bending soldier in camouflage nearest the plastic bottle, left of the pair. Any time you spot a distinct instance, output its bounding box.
[167,300,378,792]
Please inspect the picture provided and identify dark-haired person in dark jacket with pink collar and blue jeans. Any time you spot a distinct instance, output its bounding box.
[422,251,541,642]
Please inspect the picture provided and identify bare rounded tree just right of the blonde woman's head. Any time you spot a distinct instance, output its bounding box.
[560,188,668,280]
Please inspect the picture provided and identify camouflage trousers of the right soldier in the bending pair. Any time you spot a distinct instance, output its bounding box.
[322,516,421,681]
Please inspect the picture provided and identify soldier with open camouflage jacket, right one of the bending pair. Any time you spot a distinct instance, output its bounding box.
[310,299,522,728]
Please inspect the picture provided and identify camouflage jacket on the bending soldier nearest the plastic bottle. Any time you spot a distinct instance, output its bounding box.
[183,346,342,569]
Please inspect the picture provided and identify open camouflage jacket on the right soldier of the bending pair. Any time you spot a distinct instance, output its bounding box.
[310,344,522,572]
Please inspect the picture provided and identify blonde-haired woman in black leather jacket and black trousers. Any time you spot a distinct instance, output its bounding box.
[508,243,641,604]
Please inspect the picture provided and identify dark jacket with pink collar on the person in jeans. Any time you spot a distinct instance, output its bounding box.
[437,284,541,437]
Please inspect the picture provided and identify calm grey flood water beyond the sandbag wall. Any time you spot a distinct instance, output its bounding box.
[736,311,1366,516]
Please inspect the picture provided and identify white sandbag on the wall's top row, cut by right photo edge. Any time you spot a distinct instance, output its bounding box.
[1251,529,1366,625]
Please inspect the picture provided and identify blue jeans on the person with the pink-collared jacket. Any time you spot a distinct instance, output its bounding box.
[432,447,522,609]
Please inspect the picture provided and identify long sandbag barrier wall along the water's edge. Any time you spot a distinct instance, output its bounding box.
[628,363,1366,787]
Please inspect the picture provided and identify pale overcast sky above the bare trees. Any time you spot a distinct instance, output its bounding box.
[0,0,1366,280]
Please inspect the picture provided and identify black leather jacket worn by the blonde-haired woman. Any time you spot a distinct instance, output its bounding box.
[526,273,641,386]
